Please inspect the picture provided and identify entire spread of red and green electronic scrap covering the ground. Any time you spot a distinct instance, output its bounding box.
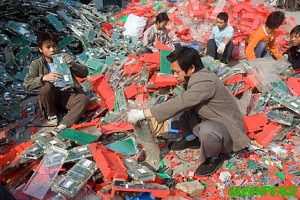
[0,0,300,200]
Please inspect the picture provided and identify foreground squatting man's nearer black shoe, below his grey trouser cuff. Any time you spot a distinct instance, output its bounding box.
[196,158,224,176]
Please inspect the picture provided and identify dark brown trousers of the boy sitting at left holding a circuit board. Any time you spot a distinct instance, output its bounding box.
[38,82,89,127]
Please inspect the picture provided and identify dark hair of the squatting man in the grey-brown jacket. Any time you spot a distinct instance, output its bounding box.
[167,46,204,73]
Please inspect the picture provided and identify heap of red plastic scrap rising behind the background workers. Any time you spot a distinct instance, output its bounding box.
[117,0,297,59]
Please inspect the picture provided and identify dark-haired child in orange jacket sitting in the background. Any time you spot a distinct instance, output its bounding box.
[245,11,284,60]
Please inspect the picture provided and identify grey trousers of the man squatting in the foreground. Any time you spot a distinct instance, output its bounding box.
[172,109,233,163]
